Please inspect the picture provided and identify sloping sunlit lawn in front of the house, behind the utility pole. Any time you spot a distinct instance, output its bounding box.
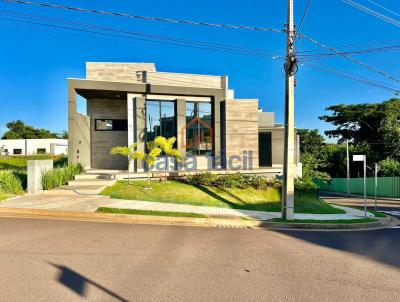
[101,181,344,214]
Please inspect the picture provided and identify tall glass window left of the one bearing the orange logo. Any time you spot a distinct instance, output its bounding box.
[146,100,176,141]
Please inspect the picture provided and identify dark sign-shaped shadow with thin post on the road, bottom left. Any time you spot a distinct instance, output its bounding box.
[50,263,128,301]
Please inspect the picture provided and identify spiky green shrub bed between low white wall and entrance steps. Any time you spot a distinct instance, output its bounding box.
[42,163,83,190]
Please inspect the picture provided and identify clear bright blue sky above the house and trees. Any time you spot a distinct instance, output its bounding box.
[0,0,400,138]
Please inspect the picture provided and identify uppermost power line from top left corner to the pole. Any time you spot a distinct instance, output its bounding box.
[0,0,285,32]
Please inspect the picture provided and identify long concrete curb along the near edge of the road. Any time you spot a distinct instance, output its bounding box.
[0,208,391,230]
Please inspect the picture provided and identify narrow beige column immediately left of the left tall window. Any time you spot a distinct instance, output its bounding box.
[133,97,146,172]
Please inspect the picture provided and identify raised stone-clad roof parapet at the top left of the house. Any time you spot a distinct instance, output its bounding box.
[86,62,156,83]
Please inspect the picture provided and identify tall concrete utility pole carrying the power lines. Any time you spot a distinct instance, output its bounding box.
[282,0,297,220]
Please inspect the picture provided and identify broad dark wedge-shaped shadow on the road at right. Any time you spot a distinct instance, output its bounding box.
[279,229,400,268]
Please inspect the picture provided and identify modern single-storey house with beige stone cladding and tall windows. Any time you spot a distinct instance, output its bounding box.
[68,62,301,175]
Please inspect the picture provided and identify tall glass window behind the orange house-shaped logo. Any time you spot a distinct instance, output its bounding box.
[186,102,213,155]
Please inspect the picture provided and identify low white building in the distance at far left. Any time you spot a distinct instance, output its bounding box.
[0,138,68,155]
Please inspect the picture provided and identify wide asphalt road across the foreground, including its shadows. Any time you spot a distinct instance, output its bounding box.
[0,218,400,301]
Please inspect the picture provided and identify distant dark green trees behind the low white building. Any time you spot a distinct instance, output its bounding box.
[2,120,60,139]
